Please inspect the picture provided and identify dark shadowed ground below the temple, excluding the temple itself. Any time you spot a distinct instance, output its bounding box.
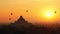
[0,22,60,34]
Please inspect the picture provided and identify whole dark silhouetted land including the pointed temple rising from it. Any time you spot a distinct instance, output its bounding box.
[0,16,60,34]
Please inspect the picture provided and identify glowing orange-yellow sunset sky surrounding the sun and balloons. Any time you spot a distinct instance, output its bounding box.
[0,0,60,22]
